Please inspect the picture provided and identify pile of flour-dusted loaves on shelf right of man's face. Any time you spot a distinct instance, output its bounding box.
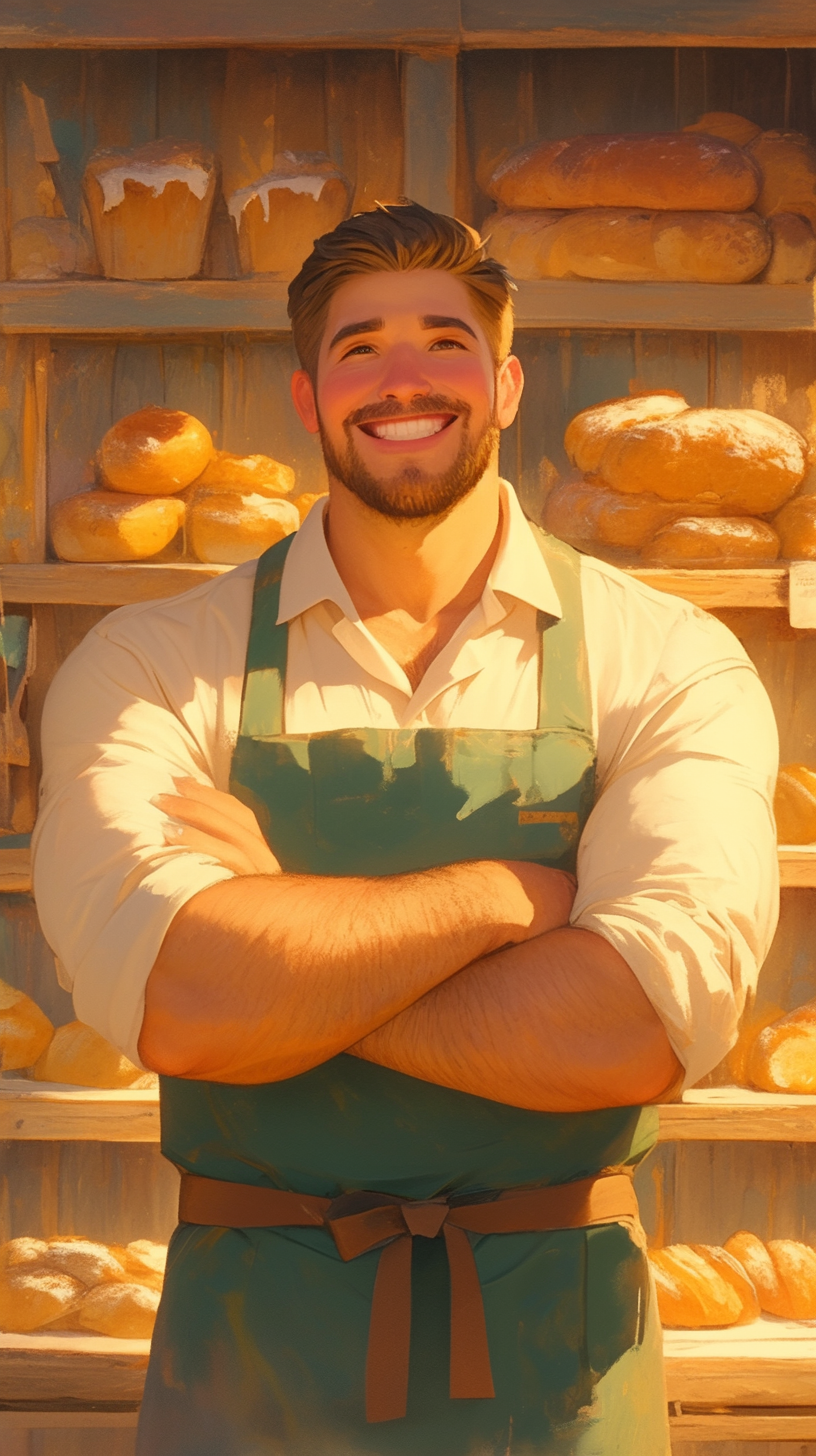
[544,390,809,568]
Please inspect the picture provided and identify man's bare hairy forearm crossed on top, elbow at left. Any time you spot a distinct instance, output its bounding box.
[140,862,571,1082]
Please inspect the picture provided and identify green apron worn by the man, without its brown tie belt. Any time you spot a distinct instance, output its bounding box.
[137,531,669,1456]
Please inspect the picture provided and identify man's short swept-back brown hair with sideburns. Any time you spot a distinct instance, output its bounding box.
[289,201,513,379]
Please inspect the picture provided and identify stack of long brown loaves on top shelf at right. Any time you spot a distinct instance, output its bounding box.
[482,112,816,282]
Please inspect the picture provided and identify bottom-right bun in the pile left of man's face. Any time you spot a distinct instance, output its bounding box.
[187,491,300,566]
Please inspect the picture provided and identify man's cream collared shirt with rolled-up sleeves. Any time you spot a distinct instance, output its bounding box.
[34,485,778,1083]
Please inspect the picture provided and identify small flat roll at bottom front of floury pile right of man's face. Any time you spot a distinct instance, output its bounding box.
[641,515,780,568]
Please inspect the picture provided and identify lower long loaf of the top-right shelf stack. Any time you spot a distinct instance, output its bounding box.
[485,207,771,282]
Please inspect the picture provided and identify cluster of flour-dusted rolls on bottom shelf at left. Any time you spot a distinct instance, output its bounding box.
[0,1236,168,1340]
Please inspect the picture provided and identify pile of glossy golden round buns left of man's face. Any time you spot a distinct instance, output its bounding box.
[51,405,300,565]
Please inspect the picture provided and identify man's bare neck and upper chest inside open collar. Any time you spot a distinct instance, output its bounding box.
[326,462,501,623]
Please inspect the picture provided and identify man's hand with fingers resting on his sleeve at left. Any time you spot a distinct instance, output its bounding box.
[152,778,281,875]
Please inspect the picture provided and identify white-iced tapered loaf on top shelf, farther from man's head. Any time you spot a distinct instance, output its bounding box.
[83,141,216,278]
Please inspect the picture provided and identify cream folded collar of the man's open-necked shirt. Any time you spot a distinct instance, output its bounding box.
[278,480,561,622]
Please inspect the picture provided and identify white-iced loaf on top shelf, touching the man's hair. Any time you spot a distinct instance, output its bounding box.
[229,151,351,278]
